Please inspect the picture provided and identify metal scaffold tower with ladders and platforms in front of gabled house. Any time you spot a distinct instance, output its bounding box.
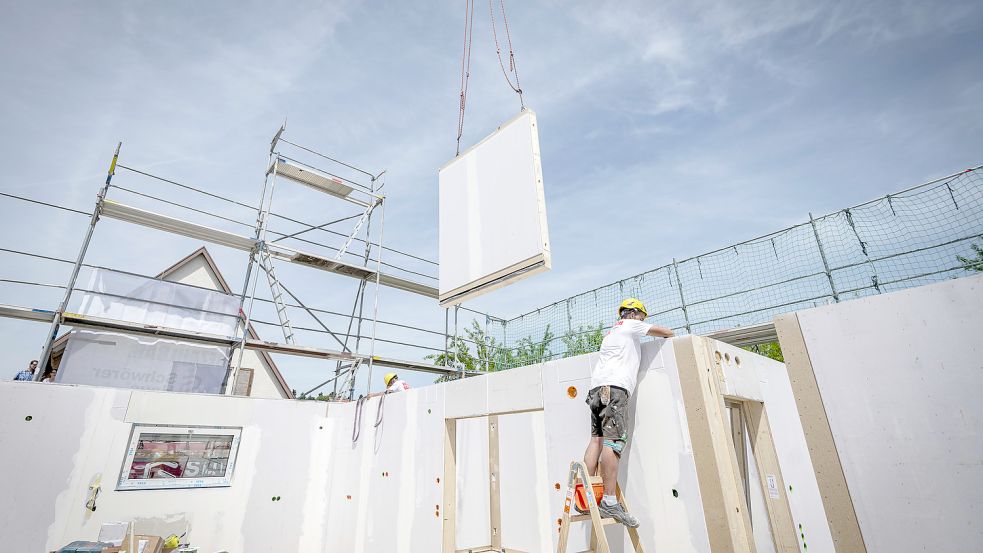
[23,123,468,398]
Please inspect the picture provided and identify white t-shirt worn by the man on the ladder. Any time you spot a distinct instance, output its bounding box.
[590,319,652,395]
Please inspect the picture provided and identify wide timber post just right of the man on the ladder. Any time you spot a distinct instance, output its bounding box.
[672,335,755,553]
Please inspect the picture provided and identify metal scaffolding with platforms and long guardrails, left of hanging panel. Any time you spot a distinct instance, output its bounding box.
[0,125,487,397]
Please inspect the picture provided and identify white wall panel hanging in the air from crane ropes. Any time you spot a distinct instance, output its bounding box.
[438,110,550,305]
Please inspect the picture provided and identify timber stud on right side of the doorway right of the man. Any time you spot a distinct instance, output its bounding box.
[741,400,799,553]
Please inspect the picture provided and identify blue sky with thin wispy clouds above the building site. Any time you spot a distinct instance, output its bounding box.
[0,0,983,389]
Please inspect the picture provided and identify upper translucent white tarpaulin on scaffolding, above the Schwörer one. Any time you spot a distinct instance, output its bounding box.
[74,269,239,336]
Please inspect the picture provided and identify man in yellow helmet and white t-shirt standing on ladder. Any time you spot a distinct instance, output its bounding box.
[577,298,674,528]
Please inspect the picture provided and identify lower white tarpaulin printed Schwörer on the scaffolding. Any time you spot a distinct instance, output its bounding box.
[57,330,229,394]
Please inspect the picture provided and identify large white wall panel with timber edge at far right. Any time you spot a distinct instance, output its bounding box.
[776,276,983,552]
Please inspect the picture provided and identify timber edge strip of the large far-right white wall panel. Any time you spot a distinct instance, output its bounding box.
[775,313,867,553]
